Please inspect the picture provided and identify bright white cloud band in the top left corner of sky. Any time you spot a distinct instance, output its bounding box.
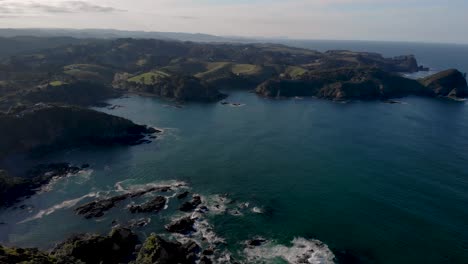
[0,0,124,14]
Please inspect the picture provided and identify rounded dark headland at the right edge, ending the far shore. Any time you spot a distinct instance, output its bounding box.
[420,69,468,98]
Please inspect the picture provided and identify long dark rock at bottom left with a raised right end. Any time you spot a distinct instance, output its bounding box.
[51,228,138,264]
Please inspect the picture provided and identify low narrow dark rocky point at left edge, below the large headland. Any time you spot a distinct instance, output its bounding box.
[0,163,81,206]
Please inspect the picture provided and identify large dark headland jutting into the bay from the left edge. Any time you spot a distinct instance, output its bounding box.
[0,104,157,158]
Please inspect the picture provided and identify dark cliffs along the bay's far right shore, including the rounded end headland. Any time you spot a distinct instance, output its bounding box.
[256,68,468,100]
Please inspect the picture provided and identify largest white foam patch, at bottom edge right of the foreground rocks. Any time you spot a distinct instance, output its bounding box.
[244,238,335,264]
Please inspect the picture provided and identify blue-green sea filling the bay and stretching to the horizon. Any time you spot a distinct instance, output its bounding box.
[0,41,468,264]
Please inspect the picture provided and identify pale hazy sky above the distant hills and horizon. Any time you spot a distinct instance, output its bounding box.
[0,0,468,43]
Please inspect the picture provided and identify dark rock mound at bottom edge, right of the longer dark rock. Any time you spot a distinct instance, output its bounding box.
[136,234,200,264]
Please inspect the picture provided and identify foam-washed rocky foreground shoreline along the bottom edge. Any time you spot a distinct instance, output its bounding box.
[0,178,361,264]
